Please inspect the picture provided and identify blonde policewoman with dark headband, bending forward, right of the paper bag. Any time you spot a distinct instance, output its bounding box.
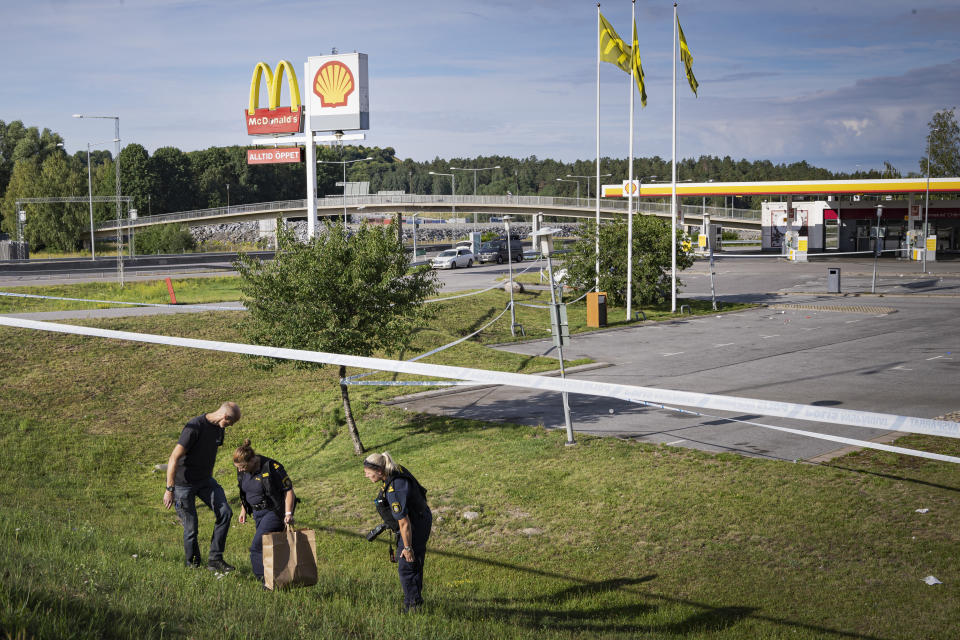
[363,452,433,613]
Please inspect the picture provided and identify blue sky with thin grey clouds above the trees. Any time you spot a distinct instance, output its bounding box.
[0,0,960,179]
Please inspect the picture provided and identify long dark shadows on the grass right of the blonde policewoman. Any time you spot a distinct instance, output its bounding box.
[323,527,882,640]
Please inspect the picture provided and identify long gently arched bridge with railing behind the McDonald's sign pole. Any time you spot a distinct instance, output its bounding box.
[97,194,760,231]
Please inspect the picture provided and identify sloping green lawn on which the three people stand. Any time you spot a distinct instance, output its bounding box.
[0,292,960,640]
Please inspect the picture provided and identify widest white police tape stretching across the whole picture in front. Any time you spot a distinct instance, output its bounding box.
[0,316,960,438]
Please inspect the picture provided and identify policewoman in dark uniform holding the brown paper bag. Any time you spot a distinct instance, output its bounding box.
[233,440,296,582]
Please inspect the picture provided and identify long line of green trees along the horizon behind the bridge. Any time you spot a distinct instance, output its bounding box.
[0,109,960,251]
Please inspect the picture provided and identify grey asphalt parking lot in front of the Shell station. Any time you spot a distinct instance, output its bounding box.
[390,254,960,460]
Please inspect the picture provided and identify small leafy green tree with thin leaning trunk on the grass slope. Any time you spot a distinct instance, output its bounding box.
[237,221,439,454]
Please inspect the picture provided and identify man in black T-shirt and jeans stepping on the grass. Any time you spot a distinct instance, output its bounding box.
[163,402,240,572]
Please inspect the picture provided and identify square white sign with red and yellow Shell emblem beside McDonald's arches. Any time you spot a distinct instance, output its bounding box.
[305,53,370,131]
